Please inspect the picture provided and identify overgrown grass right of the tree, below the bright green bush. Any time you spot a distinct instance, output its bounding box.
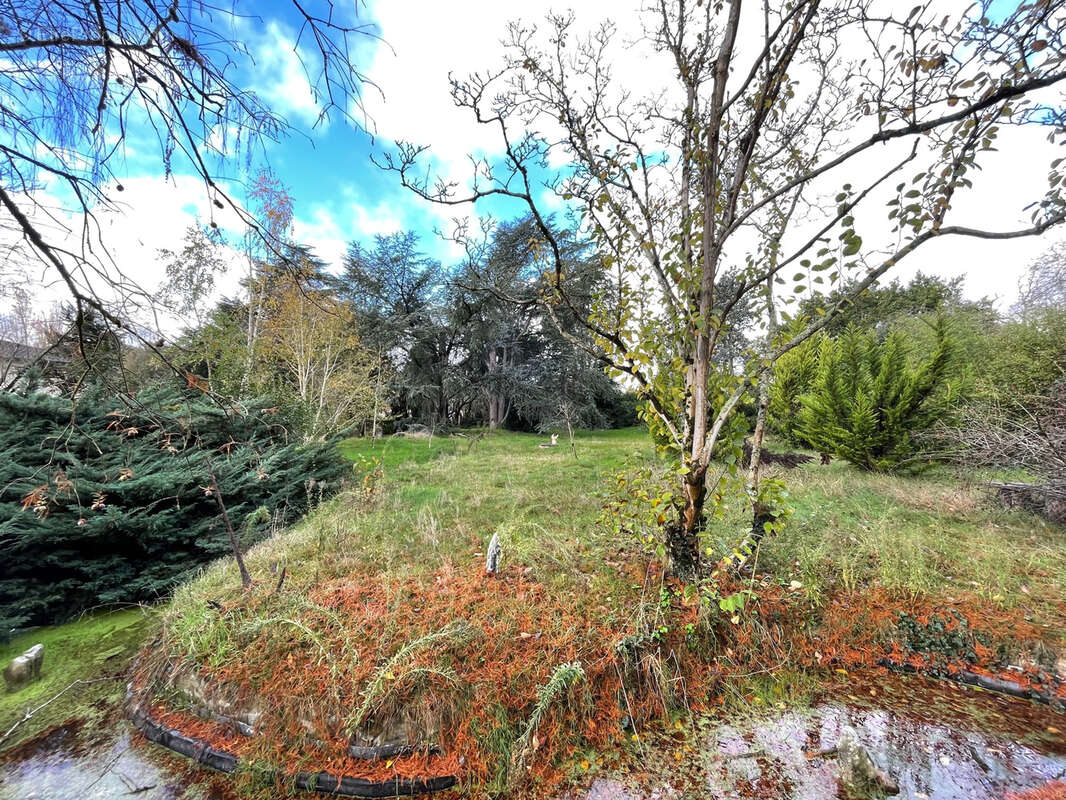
[761,461,1066,627]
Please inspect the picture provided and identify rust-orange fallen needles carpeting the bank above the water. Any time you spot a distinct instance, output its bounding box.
[142,554,1066,793]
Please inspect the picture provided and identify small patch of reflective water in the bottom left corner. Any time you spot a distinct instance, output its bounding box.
[0,722,228,800]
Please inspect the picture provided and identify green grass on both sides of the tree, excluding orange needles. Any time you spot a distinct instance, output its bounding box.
[168,429,1066,657]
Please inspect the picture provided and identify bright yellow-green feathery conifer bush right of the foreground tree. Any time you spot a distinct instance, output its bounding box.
[800,317,958,471]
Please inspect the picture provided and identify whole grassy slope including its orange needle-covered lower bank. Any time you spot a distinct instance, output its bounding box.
[152,430,1066,791]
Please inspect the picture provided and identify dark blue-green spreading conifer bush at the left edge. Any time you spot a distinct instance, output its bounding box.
[0,390,346,629]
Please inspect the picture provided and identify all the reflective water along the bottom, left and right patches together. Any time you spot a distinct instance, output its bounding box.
[0,674,1066,800]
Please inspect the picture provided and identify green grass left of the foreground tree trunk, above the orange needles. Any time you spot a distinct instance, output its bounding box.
[174,429,652,610]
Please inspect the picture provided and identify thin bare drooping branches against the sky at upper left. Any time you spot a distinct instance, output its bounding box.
[0,0,373,375]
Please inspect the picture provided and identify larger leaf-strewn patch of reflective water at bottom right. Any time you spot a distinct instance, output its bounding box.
[570,676,1066,800]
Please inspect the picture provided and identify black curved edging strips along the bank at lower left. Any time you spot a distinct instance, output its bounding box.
[130,708,456,797]
